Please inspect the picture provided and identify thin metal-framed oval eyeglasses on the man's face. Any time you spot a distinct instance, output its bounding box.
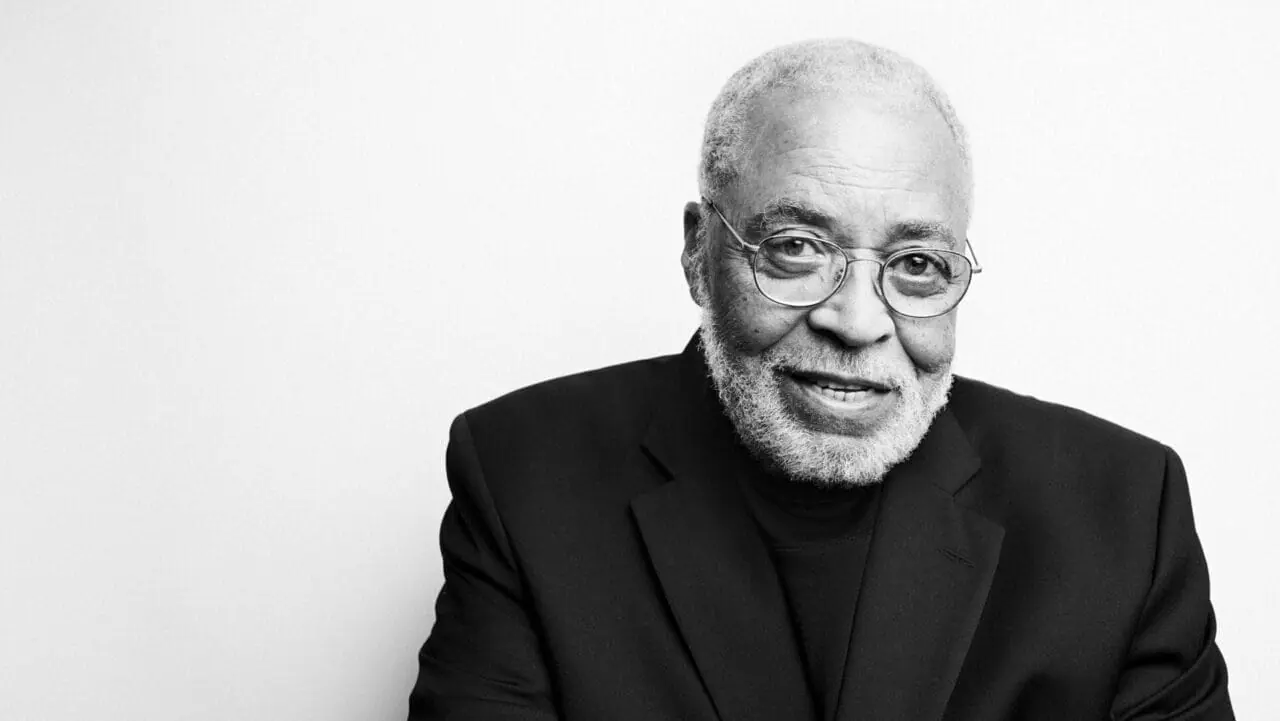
[703,197,982,318]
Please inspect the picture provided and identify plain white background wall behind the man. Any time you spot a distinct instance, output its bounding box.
[0,0,1280,721]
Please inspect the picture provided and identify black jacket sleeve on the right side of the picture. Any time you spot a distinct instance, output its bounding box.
[1111,448,1235,721]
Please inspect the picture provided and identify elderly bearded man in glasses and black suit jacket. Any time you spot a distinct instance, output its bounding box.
[410,41,1233,721]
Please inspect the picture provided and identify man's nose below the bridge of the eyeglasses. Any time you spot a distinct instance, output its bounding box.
[808,259,895,348]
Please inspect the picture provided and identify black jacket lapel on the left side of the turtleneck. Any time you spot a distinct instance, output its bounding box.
[631,344,814,721]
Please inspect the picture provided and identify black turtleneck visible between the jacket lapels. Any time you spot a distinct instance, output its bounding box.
[742,474,881,720]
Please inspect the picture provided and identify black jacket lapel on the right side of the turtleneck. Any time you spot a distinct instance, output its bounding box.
[836,410,1004,721]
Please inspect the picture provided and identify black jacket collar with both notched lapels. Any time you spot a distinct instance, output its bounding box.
[631,338,1004,721]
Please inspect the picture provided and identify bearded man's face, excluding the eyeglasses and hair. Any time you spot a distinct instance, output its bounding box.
[691,93,966,485]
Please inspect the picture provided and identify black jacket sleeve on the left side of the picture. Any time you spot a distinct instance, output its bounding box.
[408,416,557,721]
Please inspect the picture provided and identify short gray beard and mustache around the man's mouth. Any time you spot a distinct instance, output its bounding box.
[700,302,952,488]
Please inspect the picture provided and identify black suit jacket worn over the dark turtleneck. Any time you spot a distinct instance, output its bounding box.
[410,343,1233,721]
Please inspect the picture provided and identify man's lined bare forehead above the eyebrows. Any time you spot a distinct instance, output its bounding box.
[733,91,966,236]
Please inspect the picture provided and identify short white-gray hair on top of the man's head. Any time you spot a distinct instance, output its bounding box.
[699,38,973,216]
